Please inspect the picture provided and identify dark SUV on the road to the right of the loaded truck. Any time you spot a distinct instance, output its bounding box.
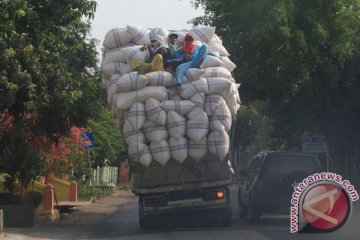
[238,152,320,221]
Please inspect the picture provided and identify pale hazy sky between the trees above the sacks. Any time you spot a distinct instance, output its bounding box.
[91,0,204,57]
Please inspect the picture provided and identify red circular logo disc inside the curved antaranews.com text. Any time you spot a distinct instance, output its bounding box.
[302,183,351,231]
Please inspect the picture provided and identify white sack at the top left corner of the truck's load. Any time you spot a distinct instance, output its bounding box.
[103,28,132,48]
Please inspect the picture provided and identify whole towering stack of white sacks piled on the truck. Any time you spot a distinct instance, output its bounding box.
[101,25,240,167]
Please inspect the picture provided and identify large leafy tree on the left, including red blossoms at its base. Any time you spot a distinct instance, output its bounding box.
[0,0,104,191]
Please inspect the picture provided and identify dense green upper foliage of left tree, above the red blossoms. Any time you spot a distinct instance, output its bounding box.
[0,0,97,135]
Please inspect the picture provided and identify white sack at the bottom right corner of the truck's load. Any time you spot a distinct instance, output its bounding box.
[208,131,230,161]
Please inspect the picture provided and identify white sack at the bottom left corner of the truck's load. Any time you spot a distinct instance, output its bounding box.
[128,142,152,167]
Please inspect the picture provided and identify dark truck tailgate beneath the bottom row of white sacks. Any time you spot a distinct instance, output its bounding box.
[132,154,230,193]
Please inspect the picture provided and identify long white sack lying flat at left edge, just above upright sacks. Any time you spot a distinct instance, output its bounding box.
[116,86,168,110]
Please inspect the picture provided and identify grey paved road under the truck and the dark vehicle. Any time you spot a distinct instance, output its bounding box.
[4,189,360,240]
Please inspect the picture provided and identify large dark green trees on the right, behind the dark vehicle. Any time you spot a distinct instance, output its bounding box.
[193,0,360,182]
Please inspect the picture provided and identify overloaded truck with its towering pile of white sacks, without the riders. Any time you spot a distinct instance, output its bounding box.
[101,25,240,227]
